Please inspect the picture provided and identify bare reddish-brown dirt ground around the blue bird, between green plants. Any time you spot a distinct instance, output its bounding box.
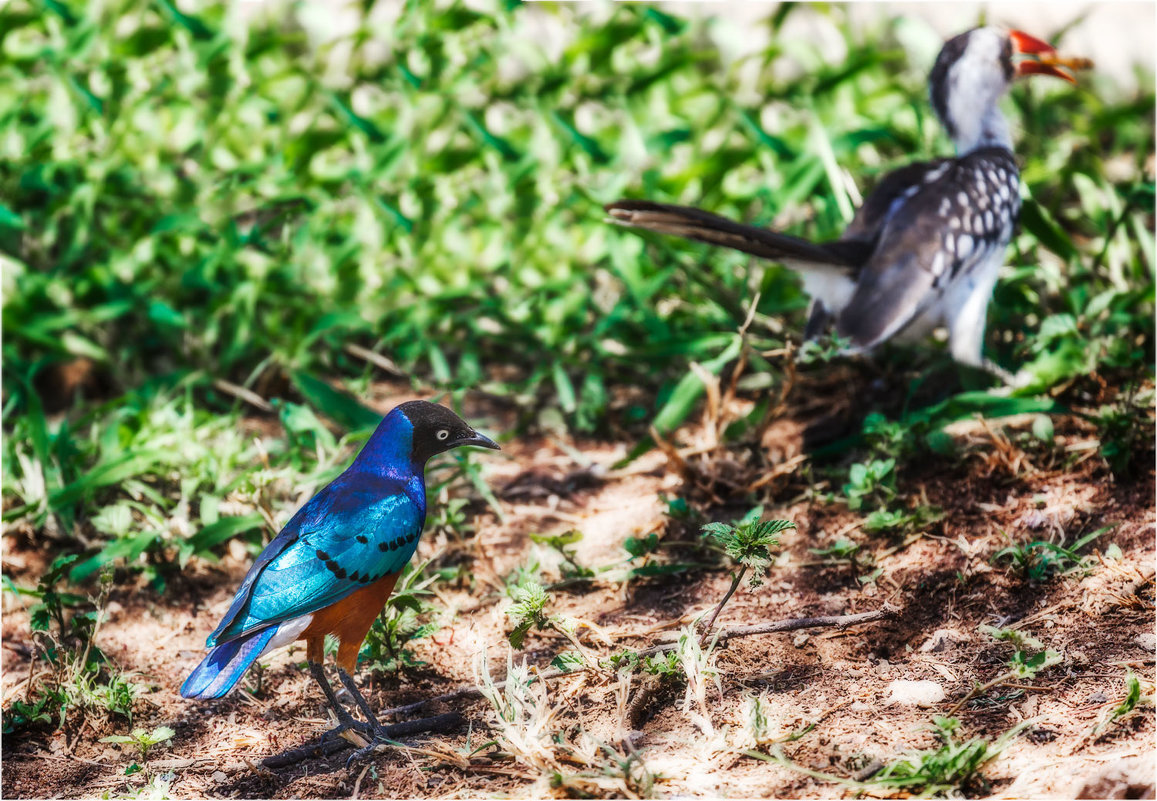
[2,372,1157,798]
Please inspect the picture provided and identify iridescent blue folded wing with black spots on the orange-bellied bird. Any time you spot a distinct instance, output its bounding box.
[208,476,426,647]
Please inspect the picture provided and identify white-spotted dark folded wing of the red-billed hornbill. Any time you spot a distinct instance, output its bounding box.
[837,148,1020,348]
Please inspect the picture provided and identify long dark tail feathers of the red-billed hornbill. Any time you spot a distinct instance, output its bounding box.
[606,200,871,271]
